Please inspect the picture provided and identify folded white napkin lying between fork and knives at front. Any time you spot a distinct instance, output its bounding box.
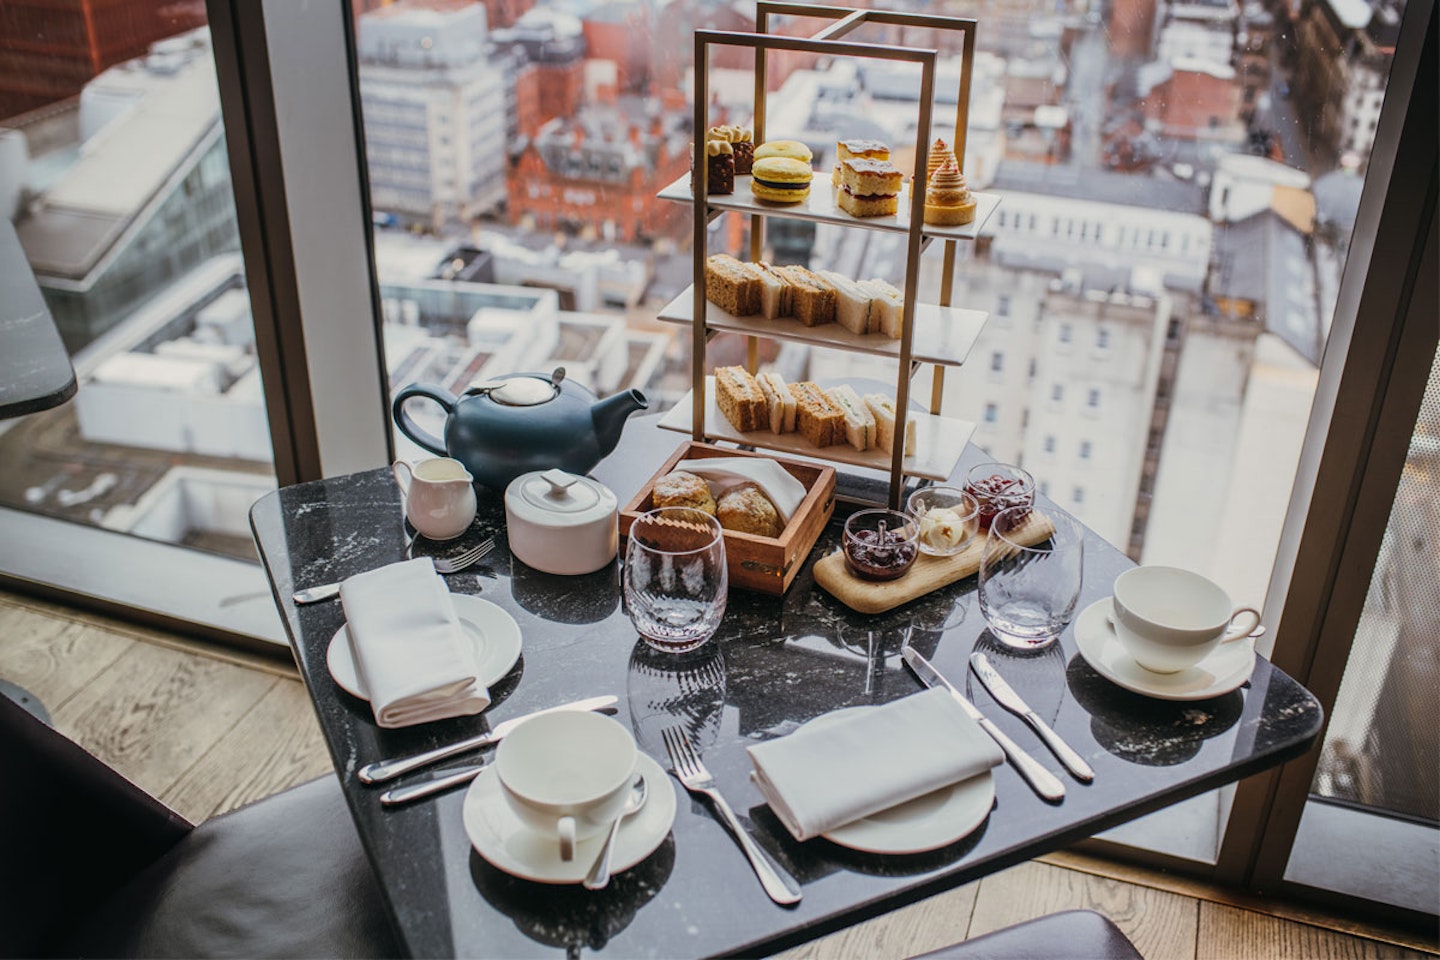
[749,689,1005,841]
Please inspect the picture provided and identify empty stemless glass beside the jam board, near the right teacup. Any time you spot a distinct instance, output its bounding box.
[979,507,1084,651]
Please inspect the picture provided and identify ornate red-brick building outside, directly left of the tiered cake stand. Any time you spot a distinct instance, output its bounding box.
[507,98,690,243]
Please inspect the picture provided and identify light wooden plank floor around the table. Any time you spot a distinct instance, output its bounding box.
[0,592,1436,960]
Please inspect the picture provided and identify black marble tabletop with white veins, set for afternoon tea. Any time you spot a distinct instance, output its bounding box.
[252,417,1320,957]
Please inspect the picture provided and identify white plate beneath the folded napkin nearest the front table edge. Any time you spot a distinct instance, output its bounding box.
[799,707,995,853]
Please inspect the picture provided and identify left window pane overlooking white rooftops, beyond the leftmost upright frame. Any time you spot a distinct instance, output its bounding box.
[0,9,275,558]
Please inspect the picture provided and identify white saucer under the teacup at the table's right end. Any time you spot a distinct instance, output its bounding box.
[1076,597,1256,699]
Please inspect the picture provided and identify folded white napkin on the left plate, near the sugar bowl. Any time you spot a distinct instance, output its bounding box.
[340,557,490,727]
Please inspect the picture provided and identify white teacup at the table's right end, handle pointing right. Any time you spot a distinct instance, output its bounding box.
[1110,567,1260,674]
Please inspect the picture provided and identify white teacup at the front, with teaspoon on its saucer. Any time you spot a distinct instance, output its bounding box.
[495,711,636,861]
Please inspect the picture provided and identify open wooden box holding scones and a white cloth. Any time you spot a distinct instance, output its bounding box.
[621,440,835,596]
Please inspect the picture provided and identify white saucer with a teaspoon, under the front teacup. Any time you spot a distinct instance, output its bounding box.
[464,753,675,884]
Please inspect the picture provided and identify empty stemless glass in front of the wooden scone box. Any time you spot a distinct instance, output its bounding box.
[624,507,730,653]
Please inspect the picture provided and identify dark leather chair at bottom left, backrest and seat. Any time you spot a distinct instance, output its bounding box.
[0,697,400,957]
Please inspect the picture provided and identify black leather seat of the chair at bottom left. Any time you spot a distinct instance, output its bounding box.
[58,776,400,957]
